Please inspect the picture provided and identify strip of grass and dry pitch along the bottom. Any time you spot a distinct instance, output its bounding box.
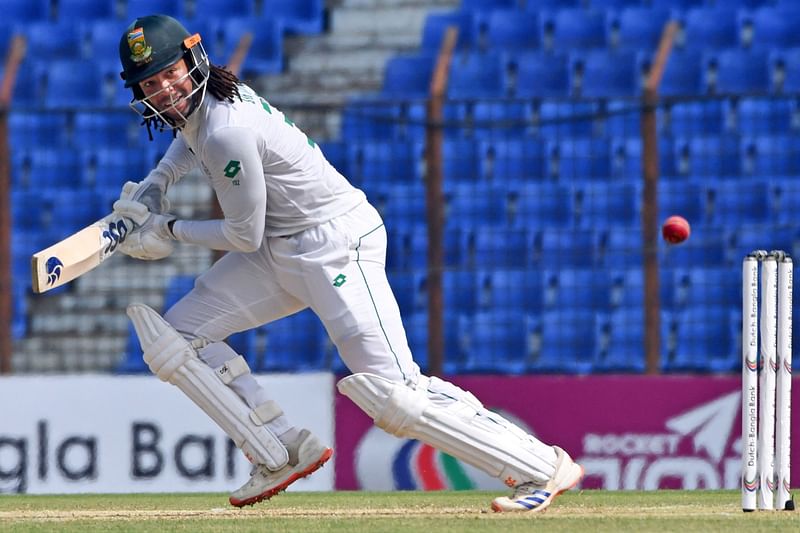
[0,490,800,533]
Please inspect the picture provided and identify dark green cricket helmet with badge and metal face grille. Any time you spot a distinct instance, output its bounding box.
[119,15,210,128]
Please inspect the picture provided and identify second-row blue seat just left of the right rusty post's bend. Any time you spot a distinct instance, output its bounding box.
[570,50,640,98]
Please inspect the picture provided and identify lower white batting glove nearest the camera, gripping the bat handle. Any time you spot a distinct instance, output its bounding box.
[114,200,175,261]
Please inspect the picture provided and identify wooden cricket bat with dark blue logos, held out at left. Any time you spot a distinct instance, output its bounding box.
[31,213,134,293]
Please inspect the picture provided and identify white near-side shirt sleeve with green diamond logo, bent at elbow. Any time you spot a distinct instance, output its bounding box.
[173,126,267,252]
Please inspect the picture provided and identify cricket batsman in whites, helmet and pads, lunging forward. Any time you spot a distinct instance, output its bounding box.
[114,15,583,512]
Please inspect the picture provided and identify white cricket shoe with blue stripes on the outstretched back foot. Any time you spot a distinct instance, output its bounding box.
[492,446,583,513]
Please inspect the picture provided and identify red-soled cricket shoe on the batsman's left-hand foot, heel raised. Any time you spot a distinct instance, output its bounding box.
[230,429,333,507]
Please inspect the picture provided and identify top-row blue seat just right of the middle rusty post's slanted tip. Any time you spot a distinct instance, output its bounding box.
[478,6,542,50]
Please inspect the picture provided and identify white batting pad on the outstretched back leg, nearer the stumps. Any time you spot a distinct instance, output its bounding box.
[337,373,556,487]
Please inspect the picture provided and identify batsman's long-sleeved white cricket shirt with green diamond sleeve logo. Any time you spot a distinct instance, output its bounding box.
[146,84,365,252]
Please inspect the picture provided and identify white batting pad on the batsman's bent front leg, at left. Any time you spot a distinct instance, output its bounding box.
[128,304,289,470]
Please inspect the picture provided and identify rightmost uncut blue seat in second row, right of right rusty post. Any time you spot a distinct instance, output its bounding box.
[704,48,772,94]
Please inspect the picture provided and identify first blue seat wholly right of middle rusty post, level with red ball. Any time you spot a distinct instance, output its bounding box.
[461,226,531,268]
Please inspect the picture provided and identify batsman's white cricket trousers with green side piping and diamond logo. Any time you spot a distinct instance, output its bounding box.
[165,201,420,383]
